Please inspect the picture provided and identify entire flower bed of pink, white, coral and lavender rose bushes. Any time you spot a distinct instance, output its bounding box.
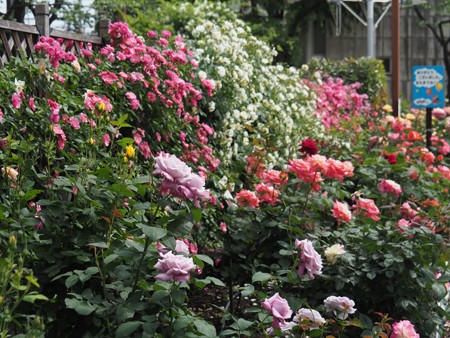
[0,12,450,338]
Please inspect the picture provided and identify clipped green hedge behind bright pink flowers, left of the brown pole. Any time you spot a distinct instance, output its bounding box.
[308,58,387,109]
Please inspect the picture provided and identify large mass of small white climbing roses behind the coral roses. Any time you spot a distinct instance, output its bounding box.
[183,2,324,167]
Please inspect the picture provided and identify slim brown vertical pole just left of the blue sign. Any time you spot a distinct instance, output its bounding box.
[391,0,400,116]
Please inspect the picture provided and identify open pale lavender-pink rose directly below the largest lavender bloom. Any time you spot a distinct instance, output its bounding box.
[155,251,195,282]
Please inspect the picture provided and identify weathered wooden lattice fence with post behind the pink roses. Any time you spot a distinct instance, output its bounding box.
[0,4,110,66]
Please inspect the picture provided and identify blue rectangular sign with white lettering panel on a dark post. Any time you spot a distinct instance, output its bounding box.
[412,66,445,108]
